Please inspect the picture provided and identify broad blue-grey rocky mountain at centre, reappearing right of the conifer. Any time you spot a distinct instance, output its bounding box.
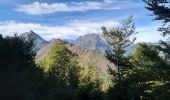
[73,34,138,55]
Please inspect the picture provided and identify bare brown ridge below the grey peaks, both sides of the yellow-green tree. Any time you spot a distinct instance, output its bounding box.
[36,39,115,73]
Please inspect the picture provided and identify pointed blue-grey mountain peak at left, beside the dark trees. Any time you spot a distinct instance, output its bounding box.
[20,30,48,52]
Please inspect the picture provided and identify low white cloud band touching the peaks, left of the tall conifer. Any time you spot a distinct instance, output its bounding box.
[0,20,118,40]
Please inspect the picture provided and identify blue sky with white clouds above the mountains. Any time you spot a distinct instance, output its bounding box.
[0,0,166,42]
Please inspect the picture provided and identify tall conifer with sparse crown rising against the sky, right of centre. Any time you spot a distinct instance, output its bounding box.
[102,17,137,100]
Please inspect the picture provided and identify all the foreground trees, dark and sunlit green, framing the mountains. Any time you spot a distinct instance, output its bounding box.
[0,0,170,100]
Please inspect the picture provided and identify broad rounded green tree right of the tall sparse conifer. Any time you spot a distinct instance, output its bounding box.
[124,44,169,100]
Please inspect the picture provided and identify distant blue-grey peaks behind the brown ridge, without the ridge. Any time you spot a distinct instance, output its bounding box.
[21,30,141,55]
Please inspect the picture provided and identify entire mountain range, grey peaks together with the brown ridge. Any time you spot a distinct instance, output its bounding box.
[20,31,147,72]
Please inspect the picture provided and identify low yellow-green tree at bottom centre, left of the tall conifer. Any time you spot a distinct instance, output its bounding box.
[78,65,102,100]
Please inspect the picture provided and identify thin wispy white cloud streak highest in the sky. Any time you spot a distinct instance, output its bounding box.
[15,0,141,15]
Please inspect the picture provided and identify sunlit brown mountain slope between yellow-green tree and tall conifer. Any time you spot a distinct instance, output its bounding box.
[66,44,115,72]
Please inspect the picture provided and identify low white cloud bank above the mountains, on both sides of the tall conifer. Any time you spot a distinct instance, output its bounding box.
[0,20,164,42]
